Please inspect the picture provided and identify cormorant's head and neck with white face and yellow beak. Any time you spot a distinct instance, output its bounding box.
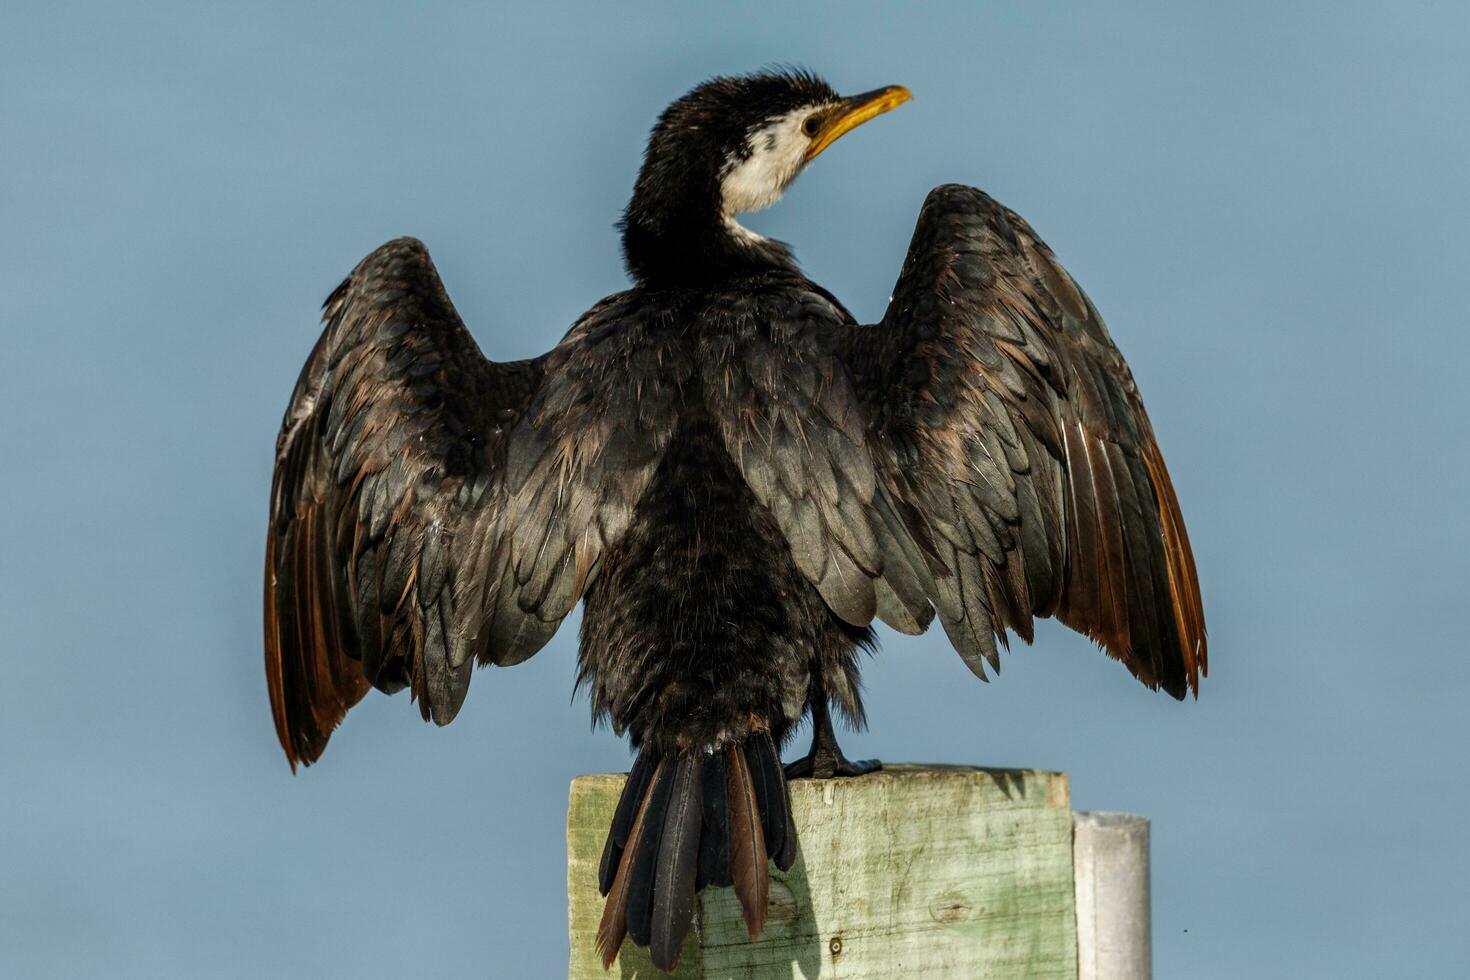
[623,71,910,282]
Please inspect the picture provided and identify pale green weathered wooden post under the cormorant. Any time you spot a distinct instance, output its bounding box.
[567,765,1078,980]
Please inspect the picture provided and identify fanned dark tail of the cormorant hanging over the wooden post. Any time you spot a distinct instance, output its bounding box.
[597,733,797,971]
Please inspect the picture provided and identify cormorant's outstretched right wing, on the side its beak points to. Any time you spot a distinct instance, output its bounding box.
[841,185,1207,698]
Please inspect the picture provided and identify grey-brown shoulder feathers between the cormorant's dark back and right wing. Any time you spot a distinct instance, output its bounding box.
[697,283,933,633]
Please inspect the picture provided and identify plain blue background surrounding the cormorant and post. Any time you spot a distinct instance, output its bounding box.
[0,0,1470,979]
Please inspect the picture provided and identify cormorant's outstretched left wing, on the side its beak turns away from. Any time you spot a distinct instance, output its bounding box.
[265,238,670,767]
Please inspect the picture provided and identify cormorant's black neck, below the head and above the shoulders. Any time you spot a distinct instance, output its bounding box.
[622,188,797,287]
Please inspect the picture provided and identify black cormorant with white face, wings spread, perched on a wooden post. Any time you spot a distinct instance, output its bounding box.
[265,72,1205,970]
